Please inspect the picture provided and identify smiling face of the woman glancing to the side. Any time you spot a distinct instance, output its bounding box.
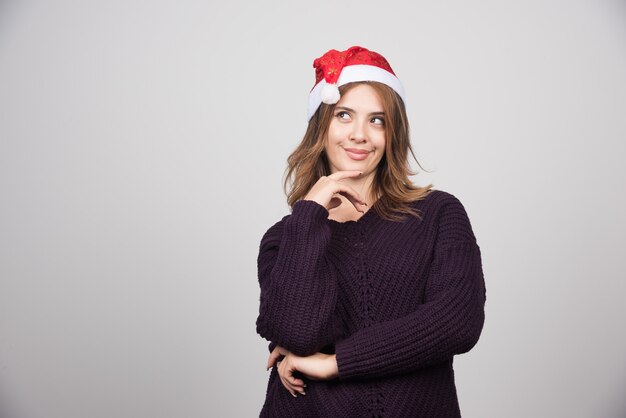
[324,84,385,176]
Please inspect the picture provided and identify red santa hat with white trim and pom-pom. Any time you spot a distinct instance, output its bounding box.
[308,46,405,120]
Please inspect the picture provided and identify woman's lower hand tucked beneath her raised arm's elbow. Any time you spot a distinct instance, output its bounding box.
[267,346,339,396]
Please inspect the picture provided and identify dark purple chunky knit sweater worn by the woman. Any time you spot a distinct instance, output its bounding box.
[256,190,486,418]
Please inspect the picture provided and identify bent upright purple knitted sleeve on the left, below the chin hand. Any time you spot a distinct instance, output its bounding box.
[256,200,337,356]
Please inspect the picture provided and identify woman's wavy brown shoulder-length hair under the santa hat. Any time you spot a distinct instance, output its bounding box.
[283,81,433,221]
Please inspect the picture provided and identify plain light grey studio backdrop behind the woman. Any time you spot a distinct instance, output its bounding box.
[0,0,626,418]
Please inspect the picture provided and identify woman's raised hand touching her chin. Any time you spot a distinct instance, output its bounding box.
[304,171,367,213]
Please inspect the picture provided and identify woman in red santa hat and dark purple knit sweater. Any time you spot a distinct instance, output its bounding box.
[256,46,485,418]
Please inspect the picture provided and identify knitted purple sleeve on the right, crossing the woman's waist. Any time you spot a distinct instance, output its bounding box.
[335,197,486,379]
